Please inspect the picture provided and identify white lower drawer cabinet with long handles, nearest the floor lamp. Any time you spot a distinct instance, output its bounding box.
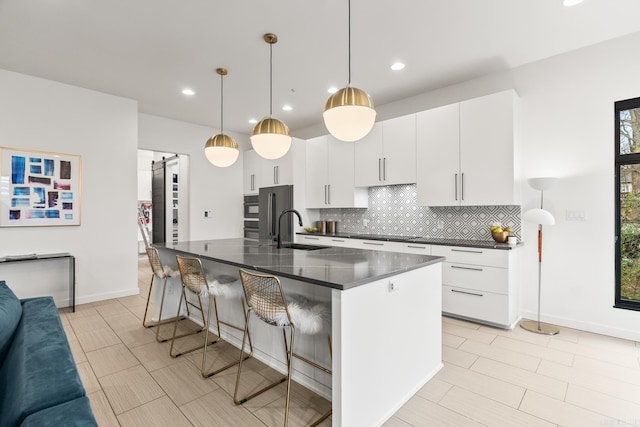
[431,245,519,328]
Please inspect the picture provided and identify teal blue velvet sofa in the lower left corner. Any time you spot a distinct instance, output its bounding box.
[0,281,98,427]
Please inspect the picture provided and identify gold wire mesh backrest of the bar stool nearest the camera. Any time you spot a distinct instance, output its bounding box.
[240,270,291,326]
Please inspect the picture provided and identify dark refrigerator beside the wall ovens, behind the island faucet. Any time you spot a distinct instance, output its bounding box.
[258,185,293,242]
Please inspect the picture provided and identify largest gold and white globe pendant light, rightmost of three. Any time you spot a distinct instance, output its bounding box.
[322,0,376,142]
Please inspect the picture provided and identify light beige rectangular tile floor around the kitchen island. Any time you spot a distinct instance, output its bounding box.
[61,258,640,427]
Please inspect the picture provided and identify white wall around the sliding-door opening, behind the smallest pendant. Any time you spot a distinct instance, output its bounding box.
[138,114,248,240]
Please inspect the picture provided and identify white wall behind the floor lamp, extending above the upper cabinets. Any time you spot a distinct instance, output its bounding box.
[297,33,640,341]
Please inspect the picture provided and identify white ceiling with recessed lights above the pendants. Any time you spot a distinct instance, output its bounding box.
[0,0,640,134]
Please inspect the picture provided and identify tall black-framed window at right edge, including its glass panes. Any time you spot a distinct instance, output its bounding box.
[615,98,640,310]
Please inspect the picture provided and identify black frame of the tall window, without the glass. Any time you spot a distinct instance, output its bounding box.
[614,97,640,311]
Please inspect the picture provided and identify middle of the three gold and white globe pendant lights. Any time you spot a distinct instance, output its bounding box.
[250,33,292,160]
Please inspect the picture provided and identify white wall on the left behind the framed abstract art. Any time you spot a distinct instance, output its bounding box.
[0,70,138,303]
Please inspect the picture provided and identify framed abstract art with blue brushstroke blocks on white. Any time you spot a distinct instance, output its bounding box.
[0,147,82,227]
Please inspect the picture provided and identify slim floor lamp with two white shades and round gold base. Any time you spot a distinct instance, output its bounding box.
[520,178,560,335]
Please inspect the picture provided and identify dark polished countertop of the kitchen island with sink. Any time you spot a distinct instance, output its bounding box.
[154,239,444,290]
